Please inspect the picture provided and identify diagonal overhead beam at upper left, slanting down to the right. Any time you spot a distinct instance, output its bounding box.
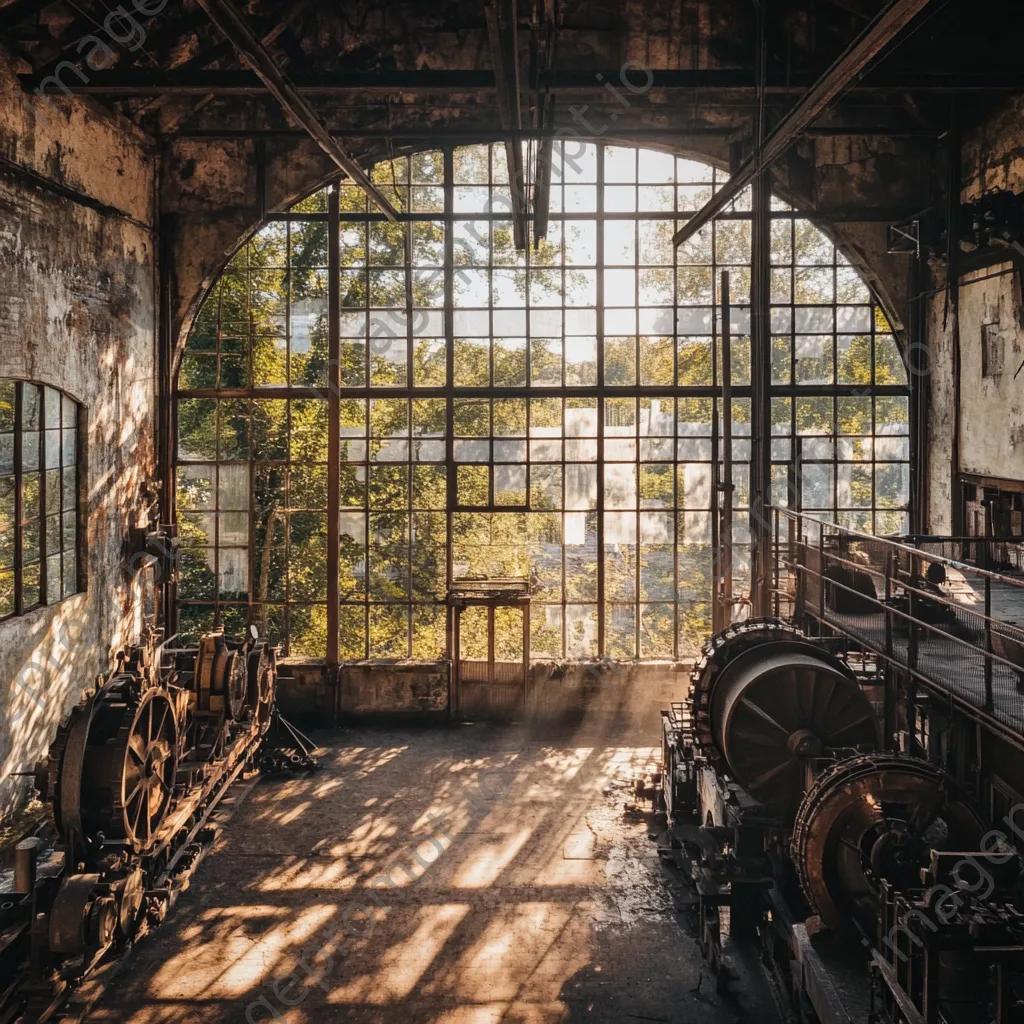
[197,0,398,221]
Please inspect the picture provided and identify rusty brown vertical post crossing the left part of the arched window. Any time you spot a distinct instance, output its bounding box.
[327,185,341,667]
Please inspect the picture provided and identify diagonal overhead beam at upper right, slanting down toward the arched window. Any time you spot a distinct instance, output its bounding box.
[672,0,930,246]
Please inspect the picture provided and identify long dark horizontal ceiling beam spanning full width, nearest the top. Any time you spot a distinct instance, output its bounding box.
[19,66,1024,96]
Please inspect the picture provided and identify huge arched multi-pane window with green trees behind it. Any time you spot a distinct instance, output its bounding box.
[177,143,909,658]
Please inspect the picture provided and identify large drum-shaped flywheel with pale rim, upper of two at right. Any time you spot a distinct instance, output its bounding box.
[691,620,881,814]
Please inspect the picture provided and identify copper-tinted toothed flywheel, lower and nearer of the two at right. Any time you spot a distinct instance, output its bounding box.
[792,754,985,930]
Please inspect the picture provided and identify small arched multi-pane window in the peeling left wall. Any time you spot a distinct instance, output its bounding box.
[0,378,81,621]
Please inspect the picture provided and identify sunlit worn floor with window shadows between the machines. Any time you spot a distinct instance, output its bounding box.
[89,719,778,1024]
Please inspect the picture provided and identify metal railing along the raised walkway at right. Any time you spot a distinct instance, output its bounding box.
[771,508,1024,732]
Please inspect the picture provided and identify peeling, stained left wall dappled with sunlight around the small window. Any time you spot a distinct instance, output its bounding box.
[0,56,156,814]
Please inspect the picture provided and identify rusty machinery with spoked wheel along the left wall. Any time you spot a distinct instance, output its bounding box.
[0,632,309,1022]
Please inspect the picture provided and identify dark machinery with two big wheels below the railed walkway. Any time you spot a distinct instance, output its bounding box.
[643,620,1024,1024]
